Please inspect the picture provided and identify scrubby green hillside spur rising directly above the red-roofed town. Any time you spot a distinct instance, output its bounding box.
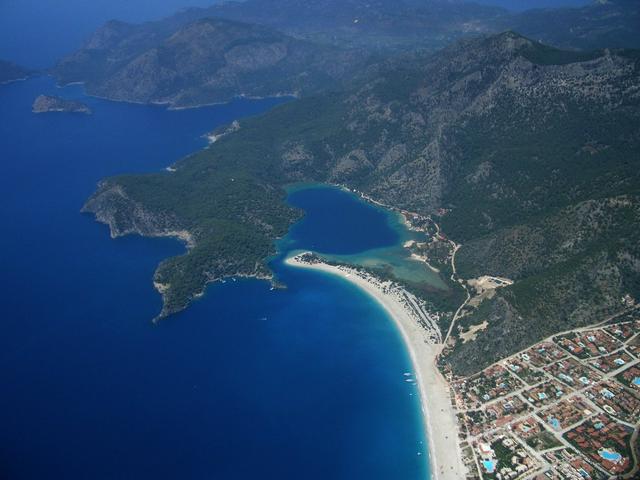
[449,195,640,374]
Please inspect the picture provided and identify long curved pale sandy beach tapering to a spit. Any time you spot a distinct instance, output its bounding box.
[285,256,466,480]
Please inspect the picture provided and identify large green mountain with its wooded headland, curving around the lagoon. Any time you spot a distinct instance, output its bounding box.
[85,32,640,360]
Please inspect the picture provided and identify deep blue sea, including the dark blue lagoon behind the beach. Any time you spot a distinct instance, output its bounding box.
[0,77,428,480]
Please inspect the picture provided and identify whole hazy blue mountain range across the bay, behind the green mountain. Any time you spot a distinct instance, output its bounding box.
[52,0,640,107]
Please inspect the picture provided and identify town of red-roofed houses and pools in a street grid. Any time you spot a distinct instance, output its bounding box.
[445,308,640,480]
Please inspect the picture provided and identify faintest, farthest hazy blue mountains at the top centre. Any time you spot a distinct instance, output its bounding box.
[200,0,506,49]
